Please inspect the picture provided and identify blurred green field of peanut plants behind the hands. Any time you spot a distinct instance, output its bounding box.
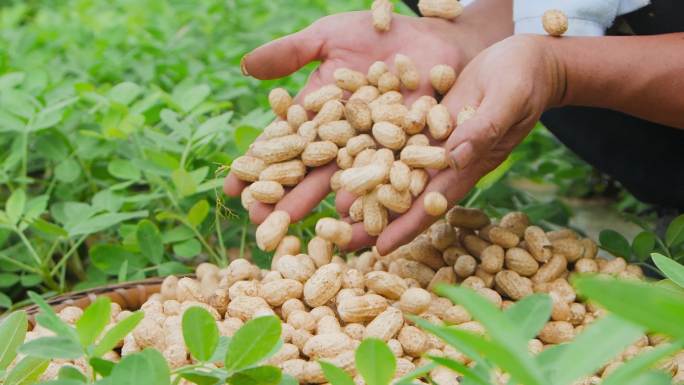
[0,0,649,308]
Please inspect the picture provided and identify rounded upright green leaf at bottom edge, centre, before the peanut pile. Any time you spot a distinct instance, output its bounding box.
[355,338,397,385]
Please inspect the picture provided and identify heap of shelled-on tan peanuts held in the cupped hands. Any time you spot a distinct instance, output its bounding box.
[231,54,468,251]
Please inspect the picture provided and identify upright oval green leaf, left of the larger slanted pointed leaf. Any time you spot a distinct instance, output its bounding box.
[183,307,219,362]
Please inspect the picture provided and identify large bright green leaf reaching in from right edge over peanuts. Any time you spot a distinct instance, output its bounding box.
[574,277,684,339]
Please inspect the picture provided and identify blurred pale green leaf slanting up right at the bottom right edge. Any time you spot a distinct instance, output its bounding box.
[550,315,644,385]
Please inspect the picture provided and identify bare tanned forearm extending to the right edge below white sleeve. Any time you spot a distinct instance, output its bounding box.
[544,33,684,129]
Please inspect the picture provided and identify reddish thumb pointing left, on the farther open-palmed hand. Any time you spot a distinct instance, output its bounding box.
[240,24,324,80]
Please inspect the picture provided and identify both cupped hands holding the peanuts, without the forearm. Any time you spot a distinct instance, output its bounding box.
[224,12,563,255]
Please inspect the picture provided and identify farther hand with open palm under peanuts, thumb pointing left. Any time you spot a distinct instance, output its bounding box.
[224,7,512,240]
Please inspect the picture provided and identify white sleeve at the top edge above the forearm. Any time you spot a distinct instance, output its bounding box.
[461,0,650,36]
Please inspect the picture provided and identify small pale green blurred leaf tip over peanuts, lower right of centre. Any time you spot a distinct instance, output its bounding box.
[504,294,553,339]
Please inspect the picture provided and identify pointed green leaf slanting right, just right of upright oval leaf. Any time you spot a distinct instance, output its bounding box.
[225,316,281,370]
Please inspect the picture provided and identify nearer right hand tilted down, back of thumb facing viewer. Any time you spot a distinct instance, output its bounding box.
[368,36,565,255]
